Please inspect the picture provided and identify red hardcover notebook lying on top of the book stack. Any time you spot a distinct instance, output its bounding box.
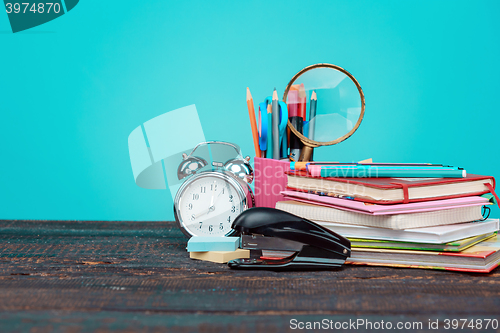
[286,171,498,204]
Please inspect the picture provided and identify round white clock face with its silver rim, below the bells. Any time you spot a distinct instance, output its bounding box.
[174,171,248,237]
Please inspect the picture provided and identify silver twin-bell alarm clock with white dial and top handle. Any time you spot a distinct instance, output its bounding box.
[174,141,254,237]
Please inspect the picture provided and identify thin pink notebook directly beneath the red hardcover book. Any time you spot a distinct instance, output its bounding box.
[281,191,490,215]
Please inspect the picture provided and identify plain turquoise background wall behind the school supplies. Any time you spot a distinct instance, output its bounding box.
[0,0,500,220]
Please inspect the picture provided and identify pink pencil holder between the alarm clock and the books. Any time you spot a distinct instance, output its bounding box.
[254,157,290,208]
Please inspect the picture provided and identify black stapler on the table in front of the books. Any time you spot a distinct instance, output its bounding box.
[228,207,351,271]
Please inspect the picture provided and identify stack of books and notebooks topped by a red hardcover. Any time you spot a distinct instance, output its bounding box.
[276,164,500,273]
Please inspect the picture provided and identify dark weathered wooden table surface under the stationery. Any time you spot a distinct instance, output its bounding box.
[0,221,500,332]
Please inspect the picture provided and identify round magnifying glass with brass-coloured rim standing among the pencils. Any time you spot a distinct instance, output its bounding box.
[283,64,365,161]
